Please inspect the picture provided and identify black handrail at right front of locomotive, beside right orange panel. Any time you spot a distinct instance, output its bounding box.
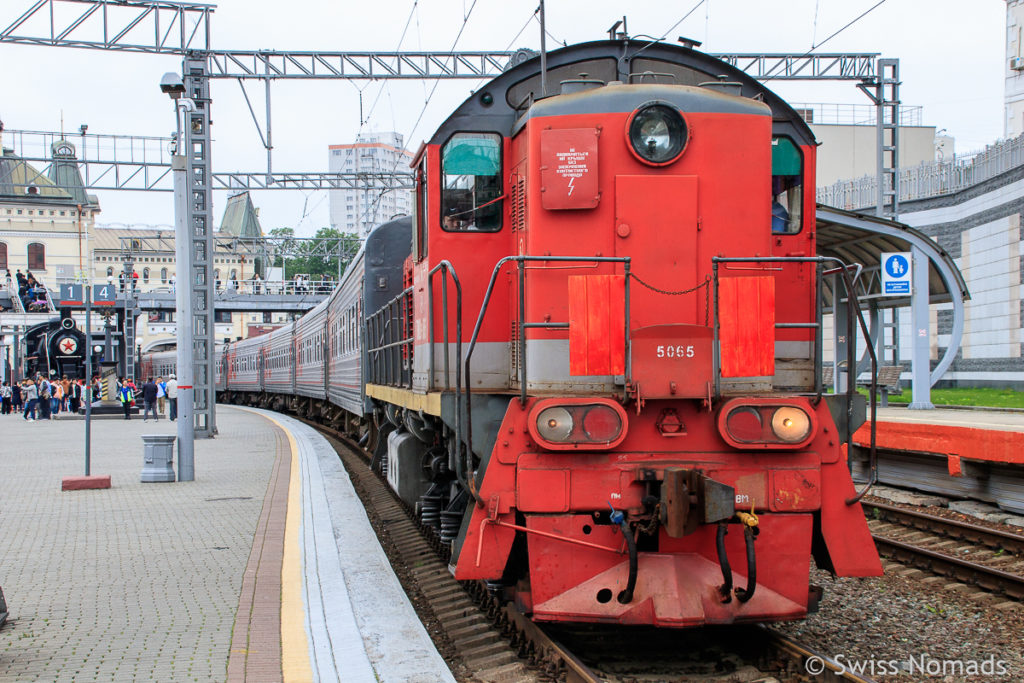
[711,256,879,505]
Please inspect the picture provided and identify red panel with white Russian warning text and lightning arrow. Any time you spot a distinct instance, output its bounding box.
[541,128,601,209]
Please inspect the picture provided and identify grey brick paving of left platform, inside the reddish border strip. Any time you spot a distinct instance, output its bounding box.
[0,408,279,682]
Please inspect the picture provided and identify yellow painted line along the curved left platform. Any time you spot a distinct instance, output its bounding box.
[262,415,313,683]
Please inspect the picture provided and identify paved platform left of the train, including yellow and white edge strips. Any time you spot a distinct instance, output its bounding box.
[0,405,455,683]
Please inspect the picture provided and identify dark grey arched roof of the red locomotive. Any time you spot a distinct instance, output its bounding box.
[430,40,816,144]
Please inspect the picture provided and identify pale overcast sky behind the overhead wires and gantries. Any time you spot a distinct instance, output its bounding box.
[0,0,1006,234]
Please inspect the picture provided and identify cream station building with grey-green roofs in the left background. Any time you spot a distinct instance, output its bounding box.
[0,139,276,374]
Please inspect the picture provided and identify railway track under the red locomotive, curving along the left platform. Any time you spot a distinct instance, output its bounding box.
[294,413,872,683]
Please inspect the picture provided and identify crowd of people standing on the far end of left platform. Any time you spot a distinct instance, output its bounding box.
[0,375,178,422]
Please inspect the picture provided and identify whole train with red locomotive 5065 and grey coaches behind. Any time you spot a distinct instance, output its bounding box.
[144,40,882,627]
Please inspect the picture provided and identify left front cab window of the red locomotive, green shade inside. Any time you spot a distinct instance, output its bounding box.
[441,133,502,232]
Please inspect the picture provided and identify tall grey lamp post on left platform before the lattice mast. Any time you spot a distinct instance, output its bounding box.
[160,72,196,481]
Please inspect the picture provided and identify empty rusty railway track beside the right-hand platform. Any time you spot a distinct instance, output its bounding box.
[864,500,1024,600]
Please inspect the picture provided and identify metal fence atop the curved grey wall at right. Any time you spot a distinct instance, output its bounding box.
[817,135,1024,210]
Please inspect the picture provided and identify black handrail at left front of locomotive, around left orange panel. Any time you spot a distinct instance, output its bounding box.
[465,256,631,489]
